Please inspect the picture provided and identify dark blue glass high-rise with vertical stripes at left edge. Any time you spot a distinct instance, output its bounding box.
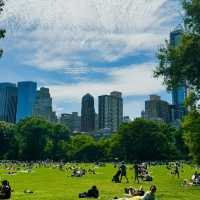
[0,83,17,123]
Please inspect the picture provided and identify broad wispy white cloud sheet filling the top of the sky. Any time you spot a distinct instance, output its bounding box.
[0,0,181,74]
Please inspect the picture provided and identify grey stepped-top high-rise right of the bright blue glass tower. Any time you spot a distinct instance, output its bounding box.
[33,87,54,122]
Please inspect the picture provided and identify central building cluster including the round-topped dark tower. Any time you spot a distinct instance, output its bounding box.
[60,91,123,135]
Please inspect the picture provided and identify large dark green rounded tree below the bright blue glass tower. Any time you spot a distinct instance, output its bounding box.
[17,117,52,160]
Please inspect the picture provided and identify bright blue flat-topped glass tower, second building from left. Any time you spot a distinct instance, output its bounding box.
[17,81,37,122]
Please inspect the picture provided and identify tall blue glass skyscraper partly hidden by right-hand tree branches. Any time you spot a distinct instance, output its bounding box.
[170,30,187,121]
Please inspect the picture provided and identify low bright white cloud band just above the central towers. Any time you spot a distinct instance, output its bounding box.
[48,63,164,102]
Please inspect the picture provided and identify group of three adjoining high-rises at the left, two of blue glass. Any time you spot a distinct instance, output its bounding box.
[0,81,57,123]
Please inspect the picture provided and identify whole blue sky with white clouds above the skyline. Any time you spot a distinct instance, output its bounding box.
[0,0,182,118]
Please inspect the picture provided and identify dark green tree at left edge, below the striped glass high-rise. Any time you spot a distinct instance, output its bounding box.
[0,122,18,159]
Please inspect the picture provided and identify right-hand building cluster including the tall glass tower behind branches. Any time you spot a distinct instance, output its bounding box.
[142,30,189,126]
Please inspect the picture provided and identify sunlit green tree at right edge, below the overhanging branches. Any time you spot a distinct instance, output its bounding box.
[182,111,200,164]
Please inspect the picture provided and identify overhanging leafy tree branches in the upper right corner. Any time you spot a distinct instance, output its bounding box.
[154,0,200,93]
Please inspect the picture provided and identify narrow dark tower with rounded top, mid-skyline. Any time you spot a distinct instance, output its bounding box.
[81,94,95,132]
